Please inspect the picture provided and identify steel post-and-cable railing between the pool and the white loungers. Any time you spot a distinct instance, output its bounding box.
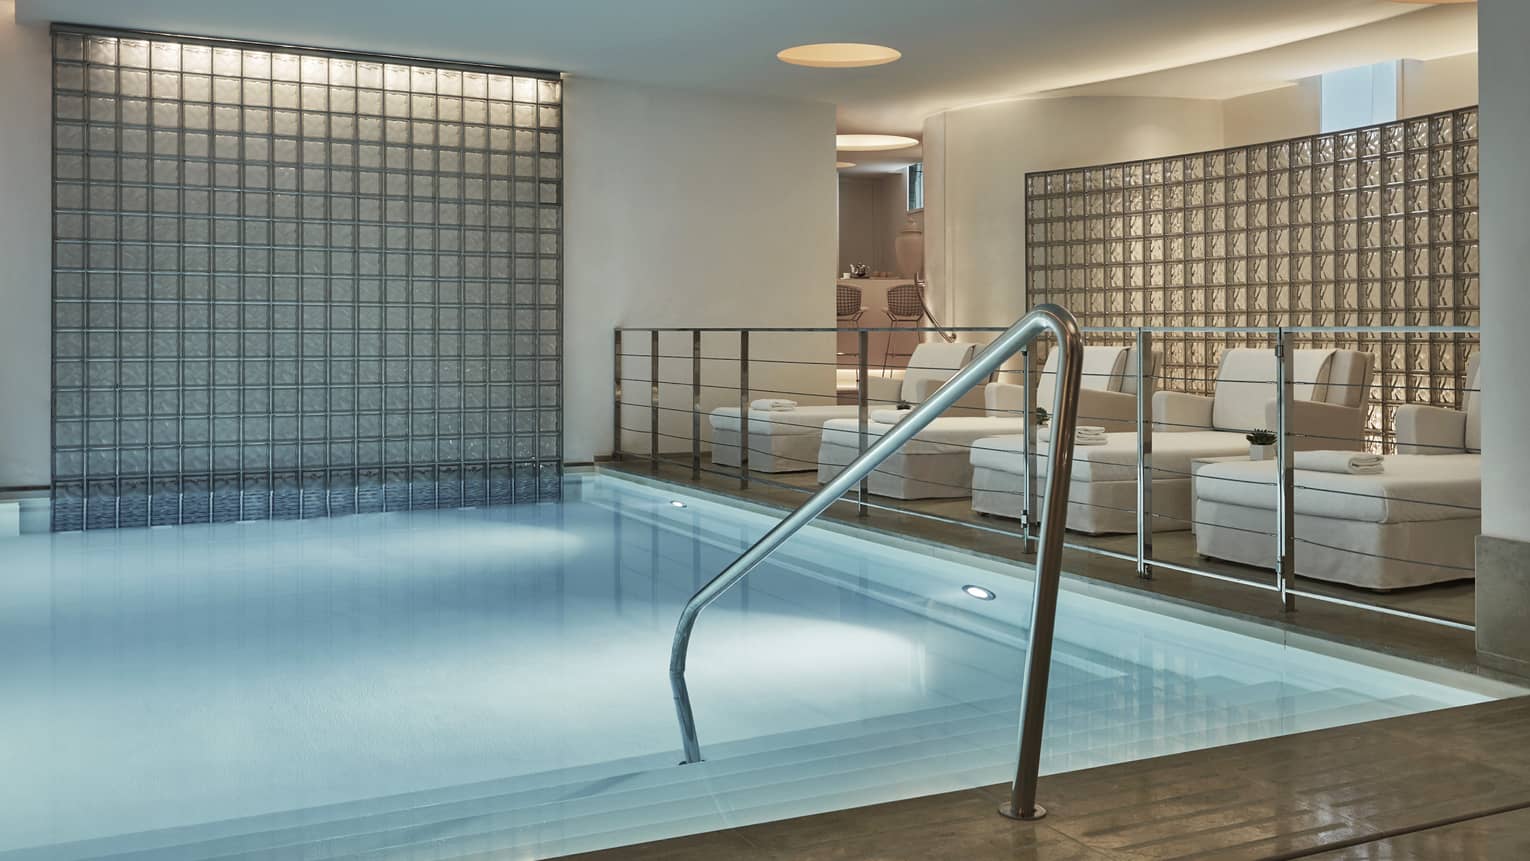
[612,324,1481,632]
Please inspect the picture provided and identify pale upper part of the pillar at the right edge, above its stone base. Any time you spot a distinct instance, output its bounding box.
[1478,0,1530,541]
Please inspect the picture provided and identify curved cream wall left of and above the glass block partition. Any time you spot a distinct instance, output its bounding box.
[924,96,1222,326]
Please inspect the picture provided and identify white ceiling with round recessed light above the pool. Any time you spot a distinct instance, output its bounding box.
[17,0,1475,146]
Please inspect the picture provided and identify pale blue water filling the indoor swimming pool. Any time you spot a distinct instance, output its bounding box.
[0,476,1515,859]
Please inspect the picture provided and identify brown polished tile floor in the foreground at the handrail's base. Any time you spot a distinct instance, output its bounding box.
[580,697,1530,861]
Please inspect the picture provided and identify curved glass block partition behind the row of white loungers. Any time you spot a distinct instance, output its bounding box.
[1027,107,1480,447]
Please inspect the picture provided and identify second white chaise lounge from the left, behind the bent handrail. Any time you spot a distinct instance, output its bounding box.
[819,346,1154,499]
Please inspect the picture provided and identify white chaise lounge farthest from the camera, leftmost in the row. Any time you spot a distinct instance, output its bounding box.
[708,341,981,473]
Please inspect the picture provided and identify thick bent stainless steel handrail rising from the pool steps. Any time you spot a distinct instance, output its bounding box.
[670,304,1083,820]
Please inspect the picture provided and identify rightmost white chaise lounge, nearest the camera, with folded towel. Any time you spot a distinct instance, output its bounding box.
[1195,358,1483,589]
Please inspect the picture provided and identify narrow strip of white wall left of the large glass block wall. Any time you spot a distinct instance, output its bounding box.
[0,0,52,488]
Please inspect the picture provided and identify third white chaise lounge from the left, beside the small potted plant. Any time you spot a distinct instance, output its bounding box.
[972,347,1372,534]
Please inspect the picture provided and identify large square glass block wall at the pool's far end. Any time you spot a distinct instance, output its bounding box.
[54,28,563,531]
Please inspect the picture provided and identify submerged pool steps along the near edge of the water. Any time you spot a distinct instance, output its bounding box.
[26,673,1432,861]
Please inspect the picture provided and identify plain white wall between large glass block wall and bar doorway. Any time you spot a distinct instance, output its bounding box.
[563,78,838,462]
